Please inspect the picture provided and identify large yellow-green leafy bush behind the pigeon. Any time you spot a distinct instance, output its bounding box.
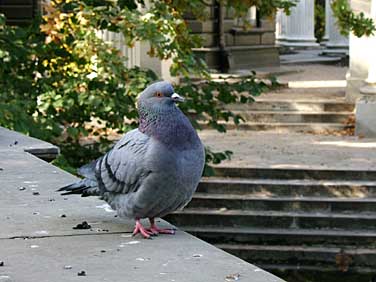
[0,0,290,172]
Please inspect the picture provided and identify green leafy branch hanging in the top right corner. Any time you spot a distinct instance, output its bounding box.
[331,0,376,37]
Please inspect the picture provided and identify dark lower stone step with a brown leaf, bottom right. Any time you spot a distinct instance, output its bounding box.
[215,244,376,269]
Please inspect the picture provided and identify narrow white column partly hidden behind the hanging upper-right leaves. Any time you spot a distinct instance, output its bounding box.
[325,0,349,49]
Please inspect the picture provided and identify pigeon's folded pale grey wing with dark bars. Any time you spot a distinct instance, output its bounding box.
[95,129,151,194]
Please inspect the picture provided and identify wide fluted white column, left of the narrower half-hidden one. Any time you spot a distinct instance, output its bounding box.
[278,0,318,47]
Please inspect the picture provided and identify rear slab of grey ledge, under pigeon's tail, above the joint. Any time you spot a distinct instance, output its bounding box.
[0,152,135,238]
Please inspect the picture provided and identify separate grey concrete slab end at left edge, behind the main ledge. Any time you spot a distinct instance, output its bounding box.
[0,127,59,160]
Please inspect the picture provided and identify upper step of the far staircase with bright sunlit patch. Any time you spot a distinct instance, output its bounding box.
[226,98,355,113]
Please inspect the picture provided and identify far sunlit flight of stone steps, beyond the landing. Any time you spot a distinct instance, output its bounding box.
[202,87,354,133]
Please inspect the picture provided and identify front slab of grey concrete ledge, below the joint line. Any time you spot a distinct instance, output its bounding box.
[0,232,281,282]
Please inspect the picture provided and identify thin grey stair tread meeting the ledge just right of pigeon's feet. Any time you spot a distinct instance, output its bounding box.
[180,226,376,238]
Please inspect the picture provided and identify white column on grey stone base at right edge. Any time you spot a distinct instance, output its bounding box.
[355,0,376,138]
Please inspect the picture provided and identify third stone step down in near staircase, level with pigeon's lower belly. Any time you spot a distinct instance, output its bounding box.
[187,193,376,212]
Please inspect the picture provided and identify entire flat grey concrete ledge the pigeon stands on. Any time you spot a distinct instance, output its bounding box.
[0,133,282,282]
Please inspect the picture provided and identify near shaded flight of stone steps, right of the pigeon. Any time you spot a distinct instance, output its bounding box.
[165,167,376,282]
